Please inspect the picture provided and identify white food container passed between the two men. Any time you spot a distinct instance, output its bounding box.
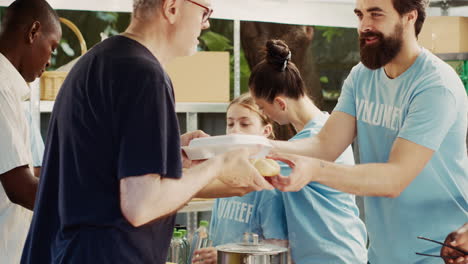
[182,134,272,160]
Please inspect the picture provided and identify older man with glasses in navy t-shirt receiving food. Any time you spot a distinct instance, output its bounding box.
[21,0,272,264]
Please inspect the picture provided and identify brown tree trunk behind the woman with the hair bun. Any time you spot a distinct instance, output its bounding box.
[241,21,323,140]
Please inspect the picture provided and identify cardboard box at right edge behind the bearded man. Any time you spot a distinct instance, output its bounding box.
[419,16,468,53]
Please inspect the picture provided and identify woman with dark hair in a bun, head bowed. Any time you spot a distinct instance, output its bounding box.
[249,40,367,264]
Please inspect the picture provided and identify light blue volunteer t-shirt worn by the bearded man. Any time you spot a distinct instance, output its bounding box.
[335,49,468,264]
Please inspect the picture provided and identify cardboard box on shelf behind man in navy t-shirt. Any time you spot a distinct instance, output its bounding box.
[167,52,229,103]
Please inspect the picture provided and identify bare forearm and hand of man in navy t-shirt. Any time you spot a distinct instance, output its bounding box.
[120,148,273,226]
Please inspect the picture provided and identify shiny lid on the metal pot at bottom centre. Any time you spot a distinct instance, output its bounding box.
[216,243,288,255]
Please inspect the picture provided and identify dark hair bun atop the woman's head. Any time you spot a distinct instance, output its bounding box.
[265,39,291,71]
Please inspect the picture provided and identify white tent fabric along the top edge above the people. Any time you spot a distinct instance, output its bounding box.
[0,0,468,27]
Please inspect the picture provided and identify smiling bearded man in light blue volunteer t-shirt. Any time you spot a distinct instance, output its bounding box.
[272,0,468,264]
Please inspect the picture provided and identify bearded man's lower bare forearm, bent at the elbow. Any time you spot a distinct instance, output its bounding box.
[307,138,434,197]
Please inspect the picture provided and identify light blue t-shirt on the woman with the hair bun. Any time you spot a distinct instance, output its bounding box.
[281,113,367,264]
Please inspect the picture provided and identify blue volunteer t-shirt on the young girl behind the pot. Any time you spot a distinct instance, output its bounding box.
[209,190,288,246]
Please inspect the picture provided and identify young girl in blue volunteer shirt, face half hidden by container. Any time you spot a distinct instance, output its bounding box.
[192,94,287,264]
